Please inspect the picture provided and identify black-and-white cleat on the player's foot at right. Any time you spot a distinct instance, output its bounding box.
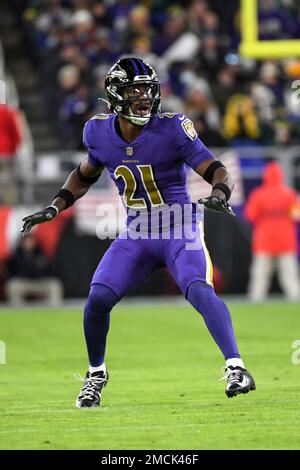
[221,366,256,398]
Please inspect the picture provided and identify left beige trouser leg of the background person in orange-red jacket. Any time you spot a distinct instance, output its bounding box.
[248,254,274,302]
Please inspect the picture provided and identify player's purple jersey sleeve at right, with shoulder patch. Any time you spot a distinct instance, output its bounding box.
[175,114,215,170]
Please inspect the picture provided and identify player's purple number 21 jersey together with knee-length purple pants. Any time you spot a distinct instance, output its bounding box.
[83,113,214,298]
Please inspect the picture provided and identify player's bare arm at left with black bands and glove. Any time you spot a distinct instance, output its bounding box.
[21,158,103,235]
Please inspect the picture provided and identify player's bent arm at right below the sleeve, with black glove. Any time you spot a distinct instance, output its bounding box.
[195,159,235,215]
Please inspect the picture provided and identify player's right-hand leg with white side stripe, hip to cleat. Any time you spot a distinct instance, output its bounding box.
[166,223,255,397]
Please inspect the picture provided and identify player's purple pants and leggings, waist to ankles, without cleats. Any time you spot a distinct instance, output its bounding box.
[84,226,240,366]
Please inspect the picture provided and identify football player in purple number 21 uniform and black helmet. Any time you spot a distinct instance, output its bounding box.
[22,58,255,408]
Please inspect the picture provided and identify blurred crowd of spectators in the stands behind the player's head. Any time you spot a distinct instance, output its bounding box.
[12,0,300,149]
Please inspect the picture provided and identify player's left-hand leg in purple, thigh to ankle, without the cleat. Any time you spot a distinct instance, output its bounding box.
[84,238,159,371]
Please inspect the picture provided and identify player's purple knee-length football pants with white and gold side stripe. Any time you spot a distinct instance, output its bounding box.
[91,226,212,299]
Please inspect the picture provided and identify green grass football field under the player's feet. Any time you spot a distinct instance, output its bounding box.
[0,303,300,450]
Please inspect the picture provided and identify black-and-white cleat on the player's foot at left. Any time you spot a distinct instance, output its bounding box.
[75,371,108,408]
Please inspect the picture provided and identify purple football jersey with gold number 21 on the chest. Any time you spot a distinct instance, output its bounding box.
[83,113,214,229]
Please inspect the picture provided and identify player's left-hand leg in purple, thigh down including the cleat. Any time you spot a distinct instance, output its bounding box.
[76,238,156,408]
